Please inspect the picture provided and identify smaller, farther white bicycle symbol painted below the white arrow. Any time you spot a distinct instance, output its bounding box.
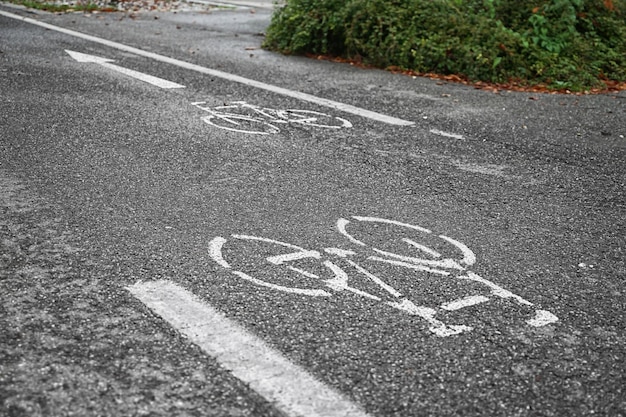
[191,101,352,135]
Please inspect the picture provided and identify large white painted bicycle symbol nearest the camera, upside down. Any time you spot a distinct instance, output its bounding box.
[209,216,558,337]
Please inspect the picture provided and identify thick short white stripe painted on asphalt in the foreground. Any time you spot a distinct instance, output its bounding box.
[127,281,368,417]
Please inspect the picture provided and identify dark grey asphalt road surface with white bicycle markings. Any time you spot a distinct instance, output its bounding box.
[0,5,626,417]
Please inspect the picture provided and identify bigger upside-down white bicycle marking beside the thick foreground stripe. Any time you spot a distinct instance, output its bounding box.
[209,216,558,337]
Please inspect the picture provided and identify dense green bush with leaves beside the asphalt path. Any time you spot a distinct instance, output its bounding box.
[265,0,626,90]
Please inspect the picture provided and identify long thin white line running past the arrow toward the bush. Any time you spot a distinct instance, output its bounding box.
[0,10,415,126]
